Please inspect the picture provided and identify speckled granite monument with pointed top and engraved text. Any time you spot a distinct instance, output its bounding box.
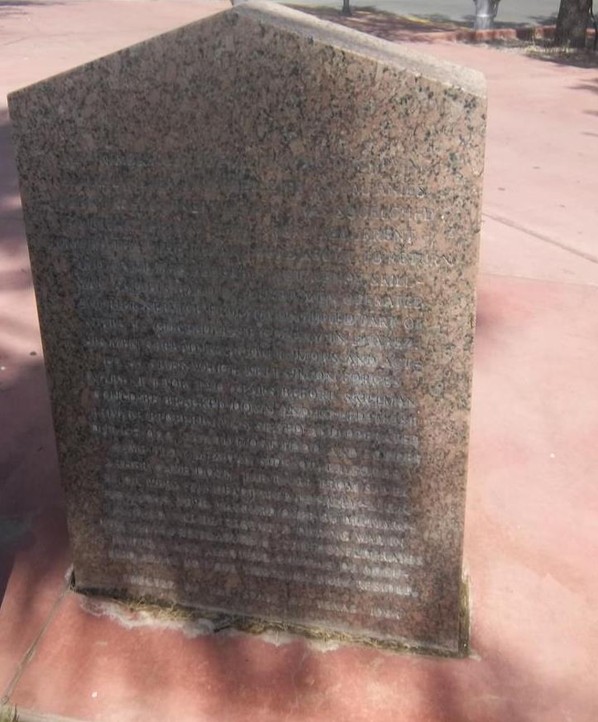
[9,3,485,652]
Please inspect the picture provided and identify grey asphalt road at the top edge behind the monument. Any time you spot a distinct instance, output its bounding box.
[285,0,559,25]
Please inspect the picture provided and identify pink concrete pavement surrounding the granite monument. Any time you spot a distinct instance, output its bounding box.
[0,0,598,722]
